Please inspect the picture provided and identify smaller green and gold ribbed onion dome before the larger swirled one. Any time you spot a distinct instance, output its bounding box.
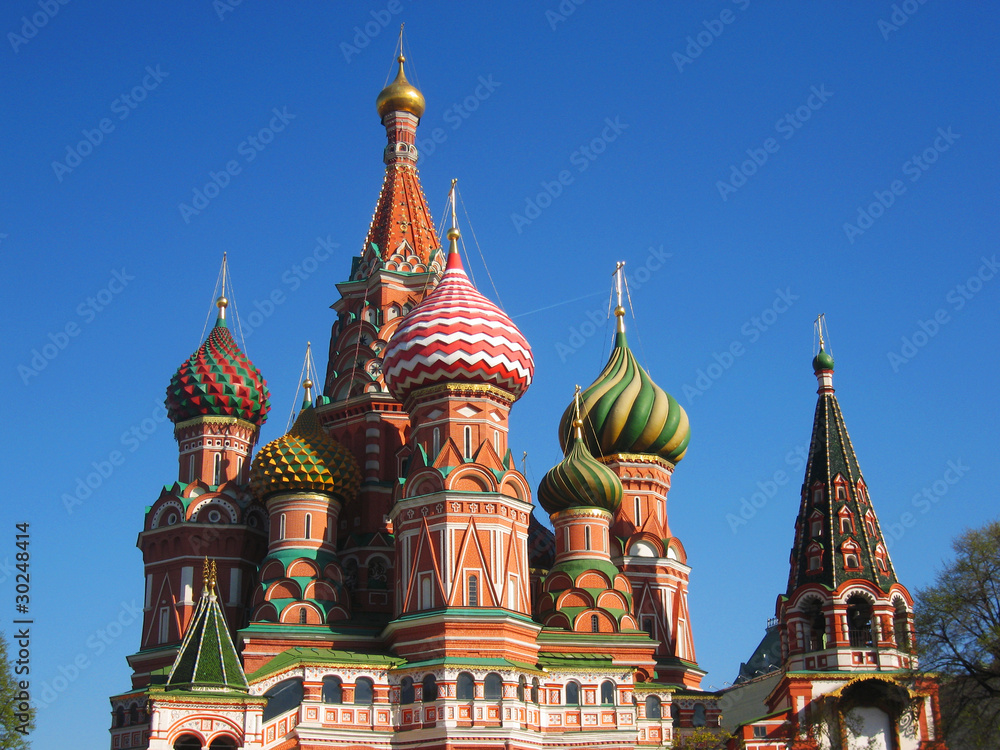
[538,419,623,513]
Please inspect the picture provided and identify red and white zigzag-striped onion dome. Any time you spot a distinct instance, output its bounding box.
[383,250,535,401]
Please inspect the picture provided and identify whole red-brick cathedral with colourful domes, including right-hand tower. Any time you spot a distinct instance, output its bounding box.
[110,51,944,750]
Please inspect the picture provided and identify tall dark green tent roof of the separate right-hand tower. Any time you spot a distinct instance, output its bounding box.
[788,344,897,595]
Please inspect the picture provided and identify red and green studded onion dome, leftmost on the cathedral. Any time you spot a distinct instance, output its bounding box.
[165,297,271,427]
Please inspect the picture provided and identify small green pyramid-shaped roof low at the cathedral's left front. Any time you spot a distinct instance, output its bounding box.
[167,558,250,693]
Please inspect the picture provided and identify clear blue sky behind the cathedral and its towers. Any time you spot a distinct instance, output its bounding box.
[0,0,1000,747]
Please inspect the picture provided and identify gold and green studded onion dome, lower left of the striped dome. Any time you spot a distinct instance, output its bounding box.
[250,403,361,504]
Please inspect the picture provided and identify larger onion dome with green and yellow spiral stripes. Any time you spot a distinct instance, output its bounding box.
[559,305,691,463]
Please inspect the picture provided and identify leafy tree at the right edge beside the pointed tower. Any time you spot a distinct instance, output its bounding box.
[916,521,1000,750]
